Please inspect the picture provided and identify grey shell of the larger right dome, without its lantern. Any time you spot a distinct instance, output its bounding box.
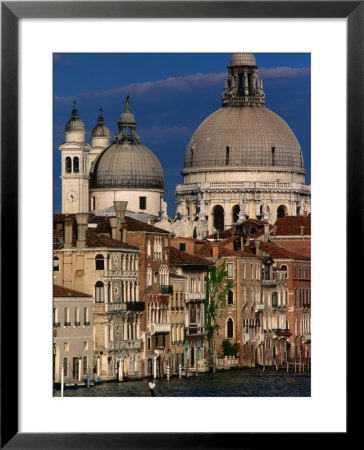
[184,106,303,173]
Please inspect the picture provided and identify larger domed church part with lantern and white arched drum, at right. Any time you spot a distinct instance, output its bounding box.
[175,53,310,238]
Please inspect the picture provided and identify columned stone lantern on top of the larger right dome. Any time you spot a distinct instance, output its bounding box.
[222,53,265,107]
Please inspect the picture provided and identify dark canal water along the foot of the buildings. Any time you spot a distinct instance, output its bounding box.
[54,369,311,397]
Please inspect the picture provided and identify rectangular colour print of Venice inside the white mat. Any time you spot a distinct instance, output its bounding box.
[50,53,311,397]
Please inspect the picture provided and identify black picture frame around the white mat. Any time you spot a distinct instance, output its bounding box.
[0,1,356,449]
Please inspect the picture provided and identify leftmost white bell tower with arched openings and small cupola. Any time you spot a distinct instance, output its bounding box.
[59,101,90,214]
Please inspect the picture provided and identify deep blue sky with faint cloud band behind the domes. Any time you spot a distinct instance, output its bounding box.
[53,53,311,216]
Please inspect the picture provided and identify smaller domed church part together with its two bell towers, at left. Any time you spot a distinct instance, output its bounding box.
[59,97,164,223]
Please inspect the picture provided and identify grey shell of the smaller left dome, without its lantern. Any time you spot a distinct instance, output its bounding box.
[90,142,164,189]
